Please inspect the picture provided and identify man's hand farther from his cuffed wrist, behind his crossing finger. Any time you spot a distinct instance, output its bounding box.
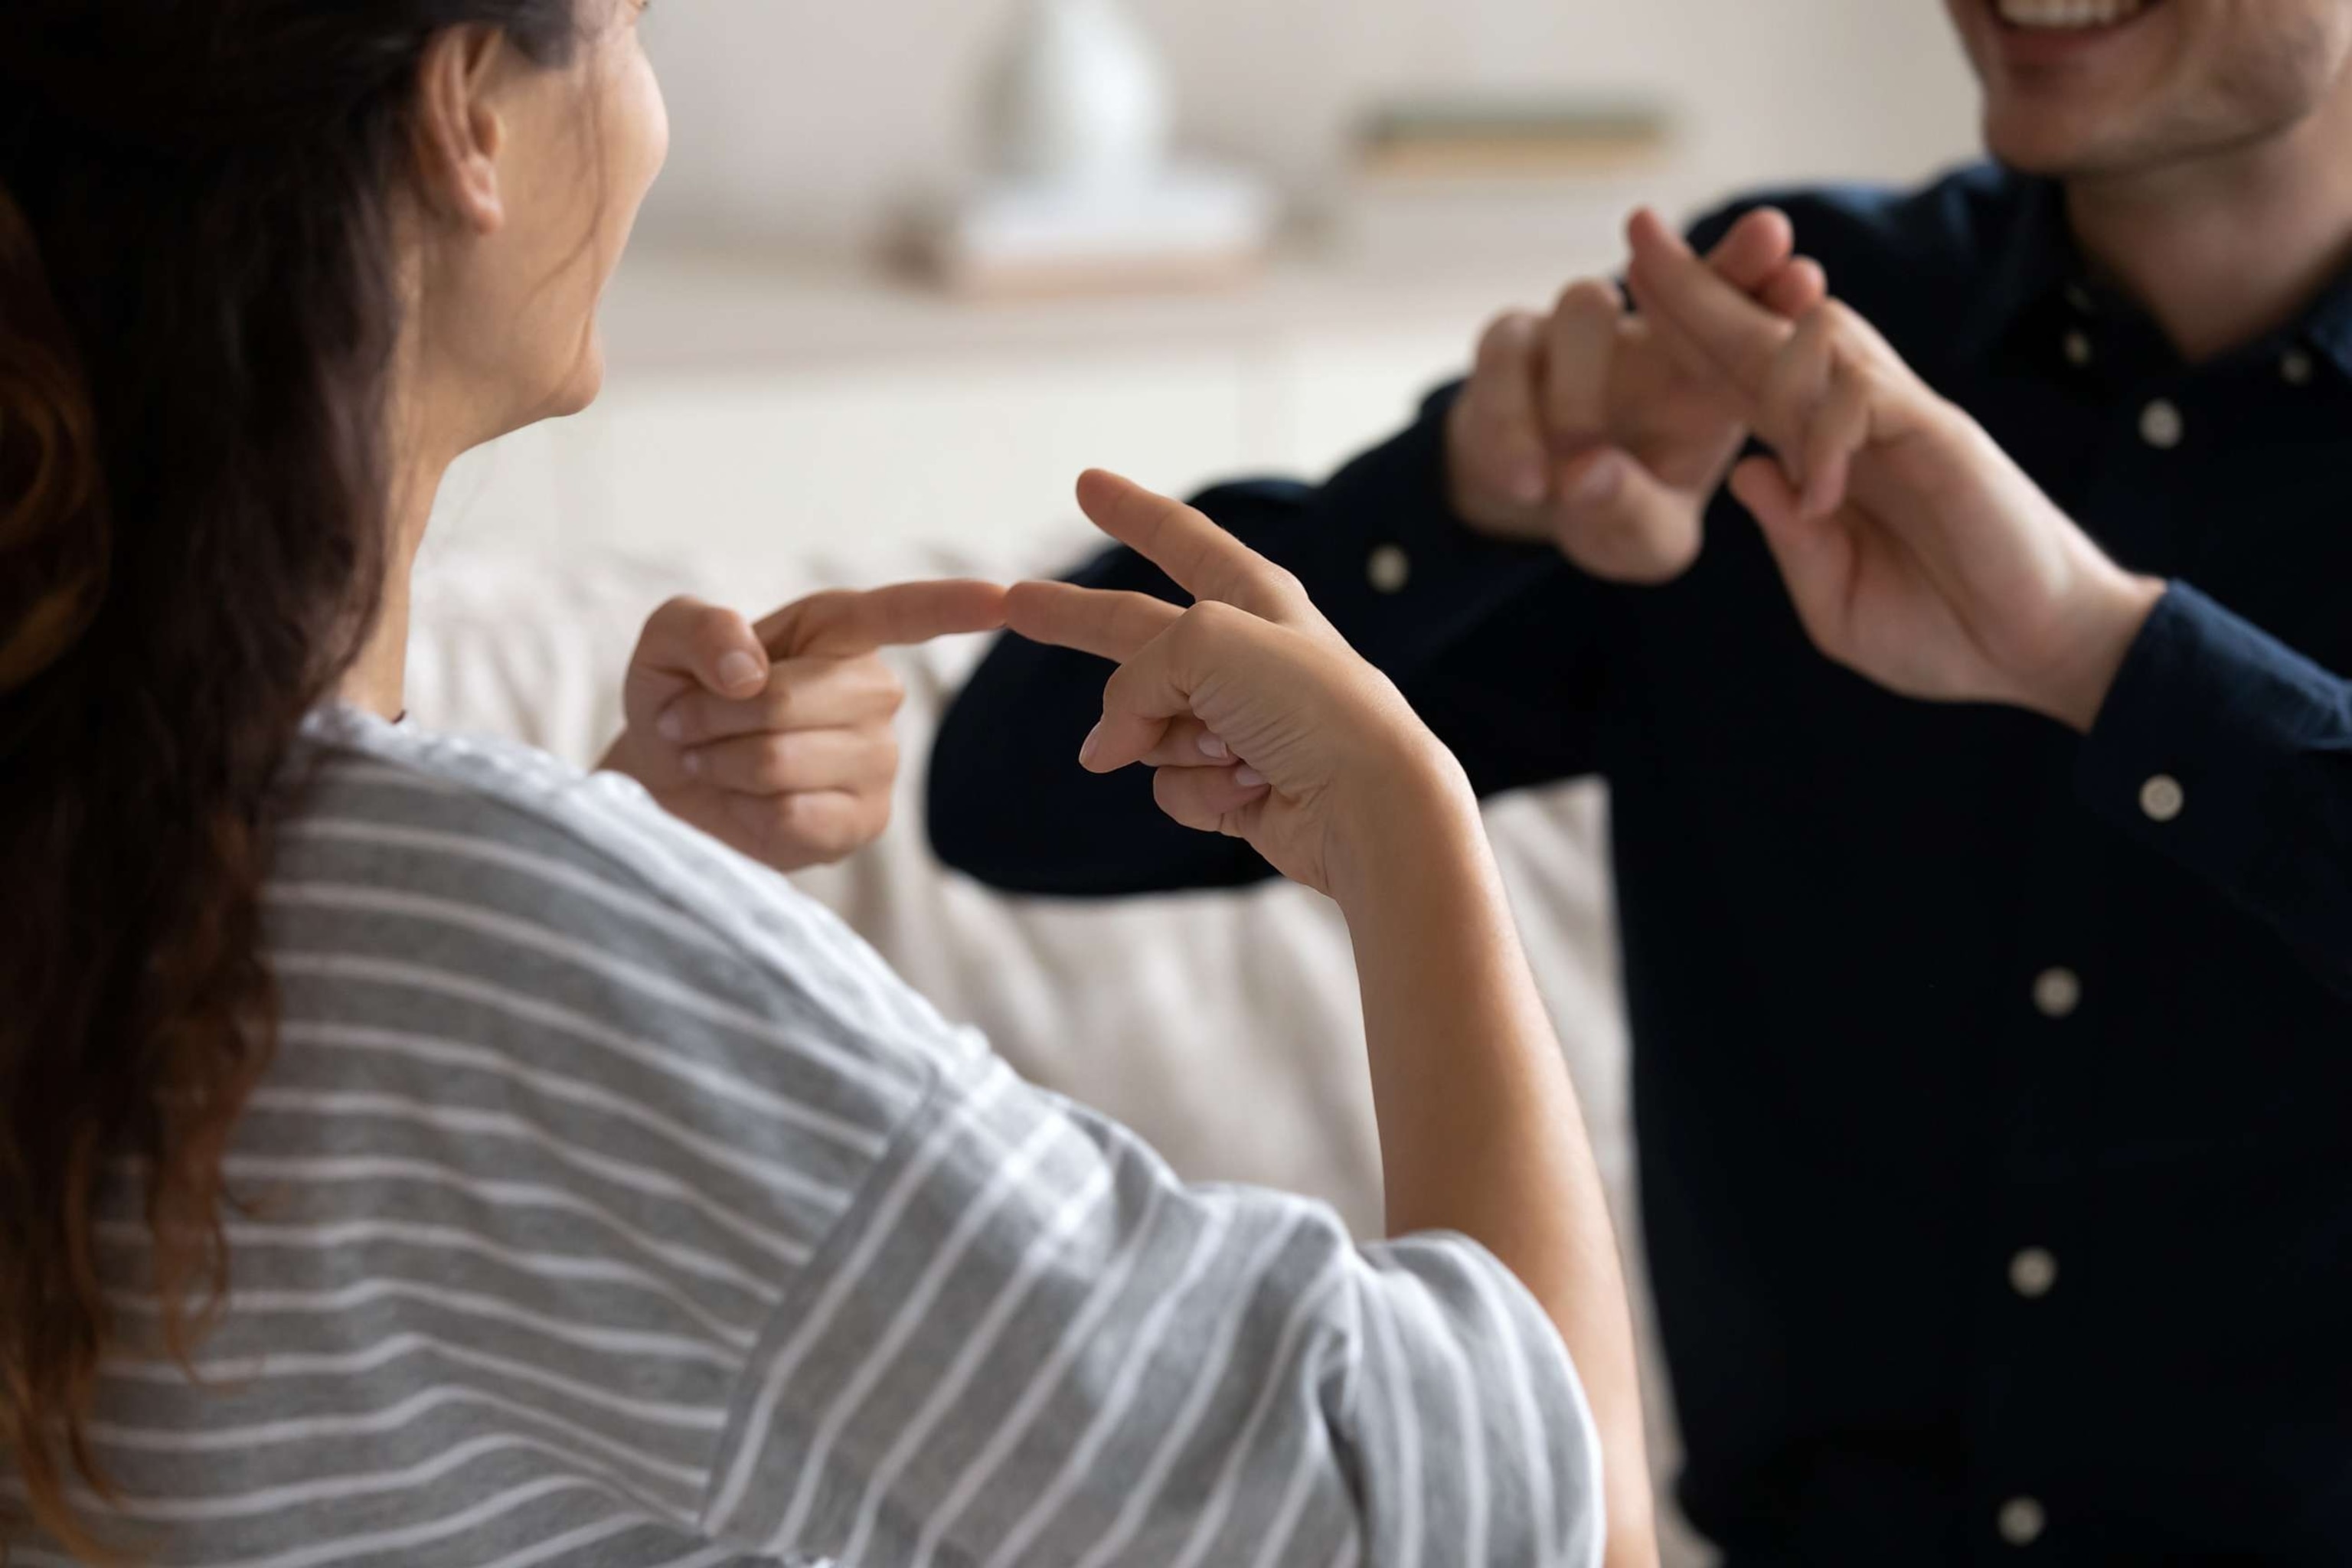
[1446,207,1825,583]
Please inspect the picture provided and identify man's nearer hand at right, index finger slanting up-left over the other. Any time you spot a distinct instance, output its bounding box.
[1630,211,2164,731]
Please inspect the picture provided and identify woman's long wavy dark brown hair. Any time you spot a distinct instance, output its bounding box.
[0,0,581,1554]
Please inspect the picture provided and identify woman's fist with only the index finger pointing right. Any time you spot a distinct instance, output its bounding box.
[605,580,1004,872]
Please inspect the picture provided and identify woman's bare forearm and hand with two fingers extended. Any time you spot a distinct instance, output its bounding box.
[1007,475,1664,1568]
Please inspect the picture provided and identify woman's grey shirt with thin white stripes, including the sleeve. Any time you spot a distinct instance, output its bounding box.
[0,712,1602,1568]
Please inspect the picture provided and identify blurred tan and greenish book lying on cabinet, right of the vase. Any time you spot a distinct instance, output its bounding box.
[1357,96,1674,181]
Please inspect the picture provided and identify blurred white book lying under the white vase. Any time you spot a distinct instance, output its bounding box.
[906,162,1279,299]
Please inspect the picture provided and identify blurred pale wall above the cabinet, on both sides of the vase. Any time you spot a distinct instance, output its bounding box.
[647,0,1973,240]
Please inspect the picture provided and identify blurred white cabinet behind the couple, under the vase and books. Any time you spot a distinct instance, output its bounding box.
[435,235,1604,576]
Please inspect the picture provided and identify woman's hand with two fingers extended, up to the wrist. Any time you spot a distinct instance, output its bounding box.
[1007,472,1475,905]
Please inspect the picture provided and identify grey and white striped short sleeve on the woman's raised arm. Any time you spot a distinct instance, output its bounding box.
[704,1058,1604,1568]
